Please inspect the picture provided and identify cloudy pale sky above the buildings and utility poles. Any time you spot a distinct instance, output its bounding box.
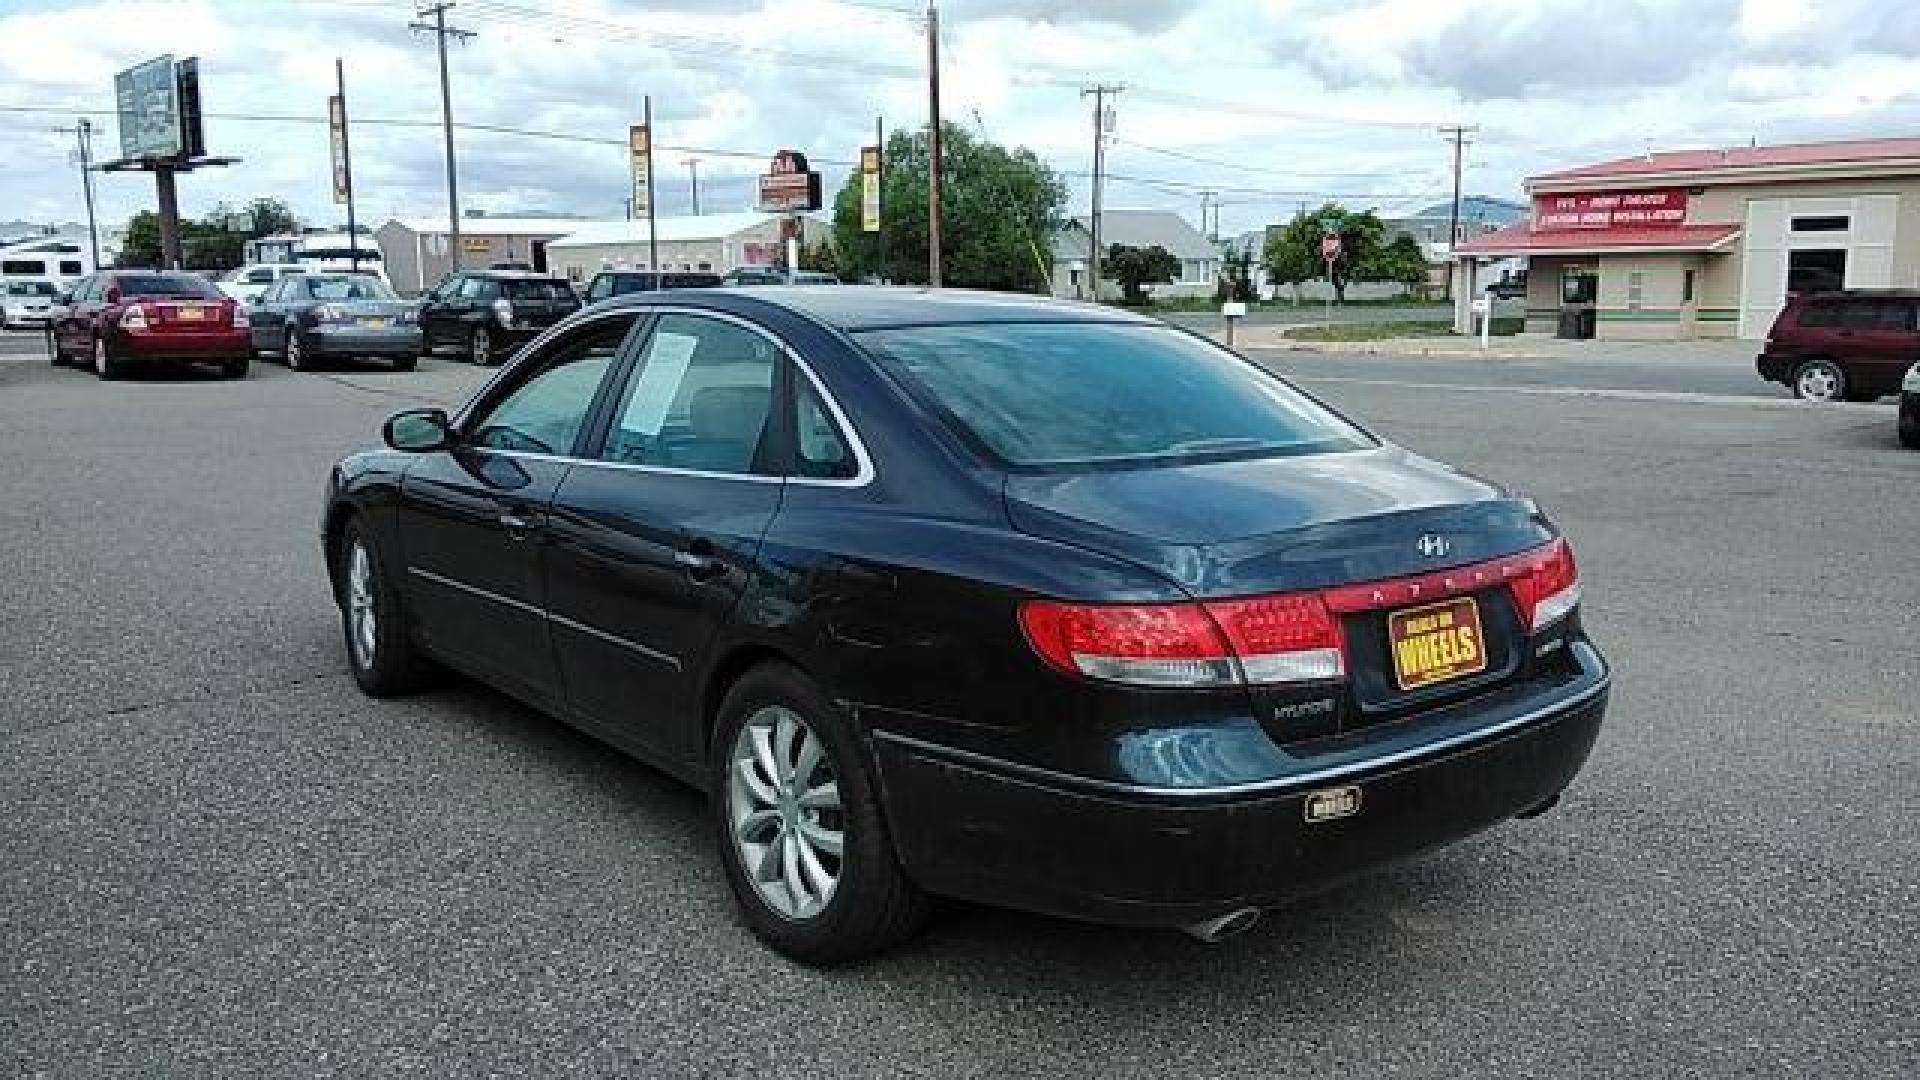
[0,0,1920,242]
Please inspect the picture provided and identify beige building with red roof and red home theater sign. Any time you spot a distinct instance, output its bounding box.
[1455,138,1920,338]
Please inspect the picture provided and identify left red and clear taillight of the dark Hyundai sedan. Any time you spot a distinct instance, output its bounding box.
[1020,600,1240,686]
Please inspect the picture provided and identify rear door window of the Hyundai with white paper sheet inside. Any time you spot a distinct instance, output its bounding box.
[601,315,780,473]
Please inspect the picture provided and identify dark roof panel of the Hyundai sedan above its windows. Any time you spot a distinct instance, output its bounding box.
[614,284,1152,332]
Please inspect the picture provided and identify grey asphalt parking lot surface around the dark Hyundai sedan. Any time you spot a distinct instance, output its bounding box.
[0,330,1920,1078]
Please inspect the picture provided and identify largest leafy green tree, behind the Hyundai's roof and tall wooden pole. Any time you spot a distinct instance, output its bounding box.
[833,125,1068,292]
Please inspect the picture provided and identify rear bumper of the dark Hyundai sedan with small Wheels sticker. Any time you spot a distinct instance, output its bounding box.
[874,641,1609,926]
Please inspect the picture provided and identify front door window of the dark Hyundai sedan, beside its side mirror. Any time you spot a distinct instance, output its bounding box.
[468,317,634,455]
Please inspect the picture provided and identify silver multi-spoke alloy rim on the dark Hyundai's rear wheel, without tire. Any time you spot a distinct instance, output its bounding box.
[726,705,847,920]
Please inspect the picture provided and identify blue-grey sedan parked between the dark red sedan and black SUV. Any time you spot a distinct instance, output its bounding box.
[252,273,420,371]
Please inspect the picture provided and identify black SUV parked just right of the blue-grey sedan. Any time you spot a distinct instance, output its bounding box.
[419,271,580,365]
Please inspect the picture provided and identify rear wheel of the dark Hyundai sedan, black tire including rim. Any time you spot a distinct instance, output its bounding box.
[708,663,927,965]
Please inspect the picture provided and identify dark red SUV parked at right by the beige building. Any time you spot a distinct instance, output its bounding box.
[1755,290,1920,402]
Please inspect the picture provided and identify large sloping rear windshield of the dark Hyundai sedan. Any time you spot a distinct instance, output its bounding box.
[858,323,1373,469]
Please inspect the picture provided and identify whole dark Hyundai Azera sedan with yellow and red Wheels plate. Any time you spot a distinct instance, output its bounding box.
[324,286,1609,963]
